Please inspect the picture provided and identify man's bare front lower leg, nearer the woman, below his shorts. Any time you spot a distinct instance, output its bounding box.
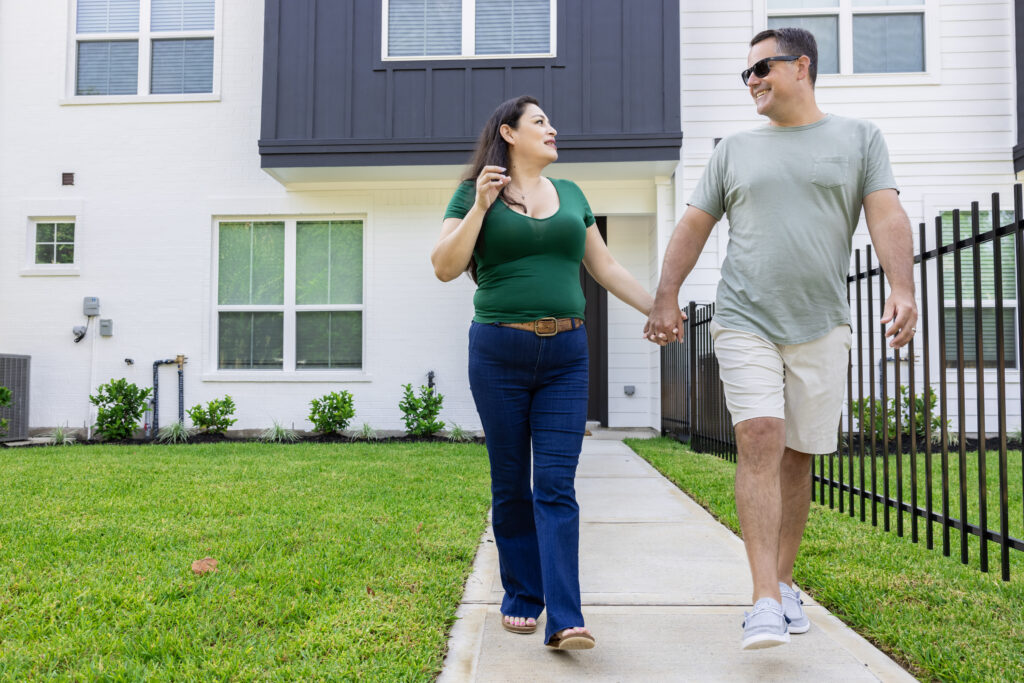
[735,418,782,603]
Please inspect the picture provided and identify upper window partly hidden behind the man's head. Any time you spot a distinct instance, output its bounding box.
[767,0,928,74]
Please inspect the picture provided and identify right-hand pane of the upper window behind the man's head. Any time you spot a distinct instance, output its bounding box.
[853,14,925,74]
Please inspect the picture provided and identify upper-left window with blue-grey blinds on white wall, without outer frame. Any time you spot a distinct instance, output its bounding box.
[75,0,216,96]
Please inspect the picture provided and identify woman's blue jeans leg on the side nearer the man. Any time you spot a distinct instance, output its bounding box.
[529,328,589,642]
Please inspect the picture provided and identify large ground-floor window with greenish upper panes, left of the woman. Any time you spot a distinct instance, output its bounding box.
[217,220,362,371]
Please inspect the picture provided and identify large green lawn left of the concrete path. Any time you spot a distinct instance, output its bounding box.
[0,443,489,681]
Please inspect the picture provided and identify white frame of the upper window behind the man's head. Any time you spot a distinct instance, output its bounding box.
[754,0,941,88]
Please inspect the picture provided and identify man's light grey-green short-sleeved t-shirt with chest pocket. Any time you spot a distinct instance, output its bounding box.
[689,114,896,344]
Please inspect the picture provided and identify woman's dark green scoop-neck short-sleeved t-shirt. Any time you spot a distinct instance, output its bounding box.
[444,178,594,323]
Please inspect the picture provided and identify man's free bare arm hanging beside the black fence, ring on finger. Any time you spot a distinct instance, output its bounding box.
[864,189,918,348]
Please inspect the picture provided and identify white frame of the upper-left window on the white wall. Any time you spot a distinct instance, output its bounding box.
[60,0,224,104]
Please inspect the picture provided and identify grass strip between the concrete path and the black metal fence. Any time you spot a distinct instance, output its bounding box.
[627,438,1024,681]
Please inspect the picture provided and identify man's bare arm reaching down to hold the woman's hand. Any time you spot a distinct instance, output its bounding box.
[643,206,718,346]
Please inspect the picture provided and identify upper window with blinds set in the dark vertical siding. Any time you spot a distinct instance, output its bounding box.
[383,0,555,59]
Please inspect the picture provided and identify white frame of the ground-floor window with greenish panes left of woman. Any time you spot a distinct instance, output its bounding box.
[203,214,372,382]
